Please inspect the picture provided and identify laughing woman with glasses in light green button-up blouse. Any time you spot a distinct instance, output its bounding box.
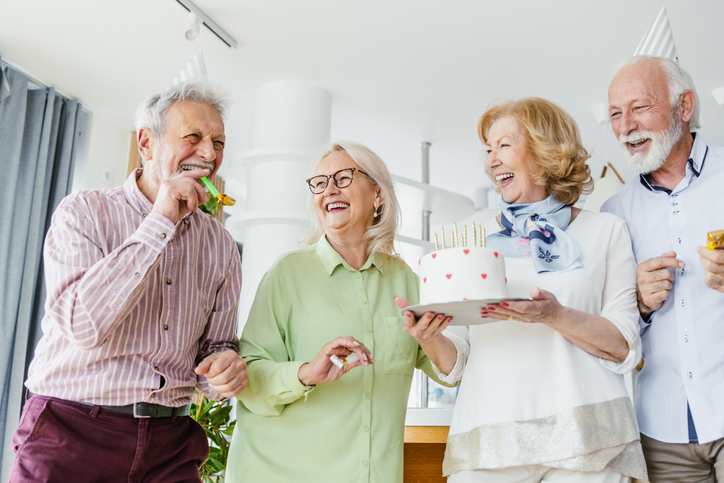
[227,142,450,483]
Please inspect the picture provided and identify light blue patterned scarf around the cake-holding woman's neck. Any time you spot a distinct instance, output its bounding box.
[486,196,581,273]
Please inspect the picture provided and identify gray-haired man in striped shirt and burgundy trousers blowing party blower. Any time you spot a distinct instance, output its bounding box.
[10,80,247,482]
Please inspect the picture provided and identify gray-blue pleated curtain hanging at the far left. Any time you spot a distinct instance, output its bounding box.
[0,59,81,481]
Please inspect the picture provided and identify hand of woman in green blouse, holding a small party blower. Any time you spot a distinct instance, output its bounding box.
[297,337,372,386]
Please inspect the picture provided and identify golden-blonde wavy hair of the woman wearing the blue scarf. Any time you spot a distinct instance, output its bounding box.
[478,97,593,205]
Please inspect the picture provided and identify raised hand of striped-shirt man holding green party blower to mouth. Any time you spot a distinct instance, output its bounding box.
[153,169,210,224]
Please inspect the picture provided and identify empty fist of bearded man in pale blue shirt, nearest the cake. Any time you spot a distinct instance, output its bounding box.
[636,252,684,319]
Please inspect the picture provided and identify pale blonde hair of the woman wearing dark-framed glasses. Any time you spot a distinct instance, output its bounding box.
[303,141,402,263]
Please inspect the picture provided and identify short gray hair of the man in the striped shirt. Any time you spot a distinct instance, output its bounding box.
[136,79,230,140]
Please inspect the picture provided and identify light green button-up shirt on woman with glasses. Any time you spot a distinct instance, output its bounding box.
[227,237,442,483]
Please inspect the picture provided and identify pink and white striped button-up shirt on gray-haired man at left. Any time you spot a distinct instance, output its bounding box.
[26,170,241,406]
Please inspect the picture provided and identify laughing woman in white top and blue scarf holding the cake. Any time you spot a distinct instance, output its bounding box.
[397,98,647,483]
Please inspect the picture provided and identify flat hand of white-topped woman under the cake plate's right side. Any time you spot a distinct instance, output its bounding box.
[480,288,564,324]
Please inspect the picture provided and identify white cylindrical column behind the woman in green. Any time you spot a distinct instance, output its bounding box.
[226,81,332,332]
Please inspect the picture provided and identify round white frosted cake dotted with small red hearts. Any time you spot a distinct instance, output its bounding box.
[420,247,508,305]
